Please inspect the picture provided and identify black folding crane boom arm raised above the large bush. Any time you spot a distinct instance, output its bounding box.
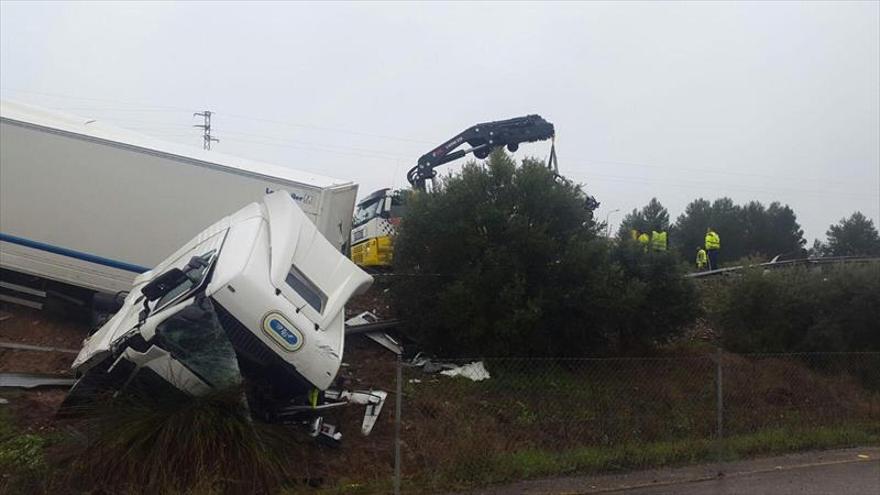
[406,115,555,190]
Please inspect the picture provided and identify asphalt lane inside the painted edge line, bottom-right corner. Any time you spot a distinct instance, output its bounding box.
[617,461,880,495]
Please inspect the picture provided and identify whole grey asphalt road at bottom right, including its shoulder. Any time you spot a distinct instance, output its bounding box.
[468,447,880,495]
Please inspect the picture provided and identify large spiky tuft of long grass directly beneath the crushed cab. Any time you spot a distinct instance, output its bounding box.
[57,390,308,494]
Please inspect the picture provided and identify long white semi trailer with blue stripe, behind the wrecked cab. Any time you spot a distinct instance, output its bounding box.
[0,101,357,306]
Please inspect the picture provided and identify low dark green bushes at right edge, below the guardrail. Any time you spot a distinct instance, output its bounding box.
[712,265,880,352]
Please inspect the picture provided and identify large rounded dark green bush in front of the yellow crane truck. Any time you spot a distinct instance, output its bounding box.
[392,152,688,356]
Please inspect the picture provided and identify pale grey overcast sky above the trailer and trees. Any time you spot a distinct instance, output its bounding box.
[0,2,880,242]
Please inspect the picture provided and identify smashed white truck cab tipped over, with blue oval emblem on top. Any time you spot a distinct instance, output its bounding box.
[64,191,385,440]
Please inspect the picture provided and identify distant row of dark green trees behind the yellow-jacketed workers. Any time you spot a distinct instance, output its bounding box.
[617,197,880,268]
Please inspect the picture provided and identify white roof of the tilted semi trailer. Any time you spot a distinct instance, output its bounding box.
[0,100,354,188]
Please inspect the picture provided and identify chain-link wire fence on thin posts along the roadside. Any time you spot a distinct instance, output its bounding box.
[386,351,880,493]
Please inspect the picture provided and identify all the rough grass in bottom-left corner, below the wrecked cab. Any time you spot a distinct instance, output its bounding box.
[0,391,322,495]
